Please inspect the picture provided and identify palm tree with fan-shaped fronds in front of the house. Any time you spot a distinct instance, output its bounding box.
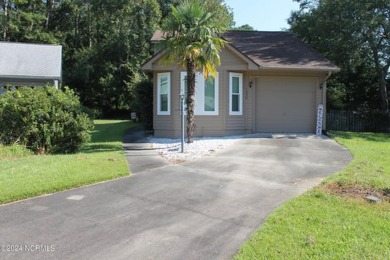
[162,0,225,143]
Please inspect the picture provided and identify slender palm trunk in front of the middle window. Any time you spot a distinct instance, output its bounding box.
[187,59,196,143]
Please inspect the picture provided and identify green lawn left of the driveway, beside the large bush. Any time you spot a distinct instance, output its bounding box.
[0,120,134,204]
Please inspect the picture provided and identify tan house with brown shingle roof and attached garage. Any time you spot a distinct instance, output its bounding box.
[142,31,339,137]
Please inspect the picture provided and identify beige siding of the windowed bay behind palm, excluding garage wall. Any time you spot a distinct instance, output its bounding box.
[153,45,252,137]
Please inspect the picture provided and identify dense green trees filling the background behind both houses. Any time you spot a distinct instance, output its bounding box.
[0,0,390,122]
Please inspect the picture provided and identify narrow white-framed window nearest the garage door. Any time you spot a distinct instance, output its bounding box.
[229,73,242,115]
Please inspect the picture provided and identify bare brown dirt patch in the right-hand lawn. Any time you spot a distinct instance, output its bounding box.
[319,182,390,202]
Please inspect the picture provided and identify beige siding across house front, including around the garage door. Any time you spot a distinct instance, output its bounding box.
[153,46,326,138]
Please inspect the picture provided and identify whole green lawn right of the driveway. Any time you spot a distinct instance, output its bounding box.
[235,132,390,259]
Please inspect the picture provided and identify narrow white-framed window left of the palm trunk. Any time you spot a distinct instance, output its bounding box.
[157,72,171,115]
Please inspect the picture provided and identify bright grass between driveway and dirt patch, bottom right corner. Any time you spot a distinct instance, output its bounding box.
[235,190,390,259]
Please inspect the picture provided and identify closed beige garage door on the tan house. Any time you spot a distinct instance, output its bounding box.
[255,78,316,133]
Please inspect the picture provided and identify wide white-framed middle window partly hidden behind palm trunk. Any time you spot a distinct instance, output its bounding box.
[180,72,219,116]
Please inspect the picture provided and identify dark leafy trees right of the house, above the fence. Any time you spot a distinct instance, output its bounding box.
[289,0,390,112]
